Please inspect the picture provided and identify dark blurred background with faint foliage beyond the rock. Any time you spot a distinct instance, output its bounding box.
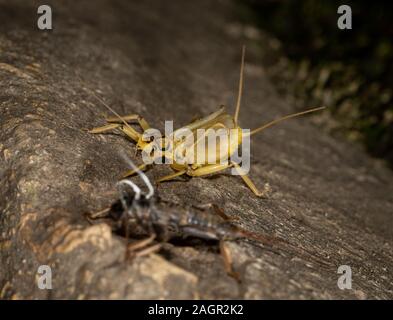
[238,0,393,167]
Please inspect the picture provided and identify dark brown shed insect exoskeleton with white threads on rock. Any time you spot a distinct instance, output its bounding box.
[87,154,280,280]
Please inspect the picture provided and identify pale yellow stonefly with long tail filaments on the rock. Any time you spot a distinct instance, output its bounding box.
[89,46,324,196]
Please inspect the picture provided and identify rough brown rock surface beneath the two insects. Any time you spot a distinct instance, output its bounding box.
[0,0,393,299]
